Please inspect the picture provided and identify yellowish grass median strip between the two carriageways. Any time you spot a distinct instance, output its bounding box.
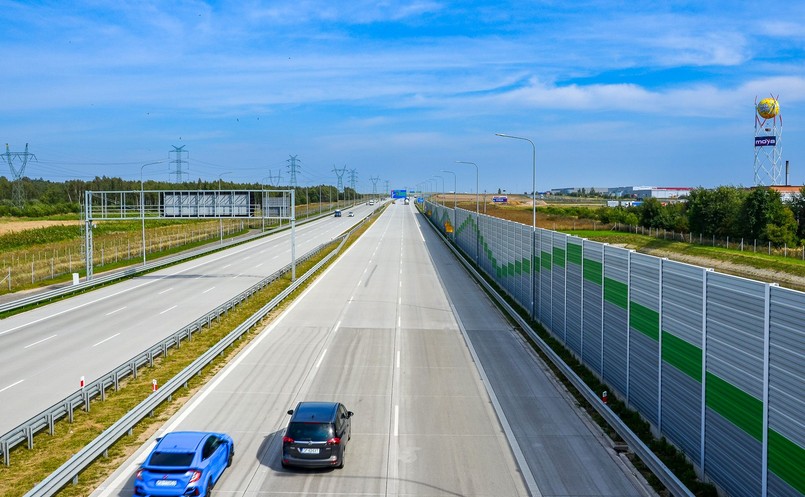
[0,206,382,497]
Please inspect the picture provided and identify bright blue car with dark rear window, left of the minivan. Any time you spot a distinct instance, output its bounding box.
[134,431,235,497]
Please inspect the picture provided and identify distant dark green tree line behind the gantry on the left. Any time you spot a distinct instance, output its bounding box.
[0,176,361,217]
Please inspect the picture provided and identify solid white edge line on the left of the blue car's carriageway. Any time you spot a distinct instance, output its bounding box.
[95,219,370,497]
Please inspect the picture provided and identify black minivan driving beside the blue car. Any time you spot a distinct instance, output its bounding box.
[281,402,352,468]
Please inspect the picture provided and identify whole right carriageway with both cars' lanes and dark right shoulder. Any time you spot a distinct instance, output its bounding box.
[92,200,646,497]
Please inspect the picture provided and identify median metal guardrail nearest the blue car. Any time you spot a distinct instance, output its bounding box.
[25,234,348,497]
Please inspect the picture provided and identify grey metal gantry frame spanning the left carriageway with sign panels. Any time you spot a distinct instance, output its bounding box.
[84,190,296,281]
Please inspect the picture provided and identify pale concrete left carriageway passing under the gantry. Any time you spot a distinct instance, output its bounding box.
[0,205,379,434]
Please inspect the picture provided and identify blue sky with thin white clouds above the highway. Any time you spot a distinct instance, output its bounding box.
[0,0,805,192]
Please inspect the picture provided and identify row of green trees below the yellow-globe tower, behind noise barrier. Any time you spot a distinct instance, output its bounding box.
[596,186,805,247]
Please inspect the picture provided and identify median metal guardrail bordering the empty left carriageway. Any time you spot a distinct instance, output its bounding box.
[0,234,332,466]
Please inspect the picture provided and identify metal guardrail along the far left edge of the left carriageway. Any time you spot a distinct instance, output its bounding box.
[0,205,342,314]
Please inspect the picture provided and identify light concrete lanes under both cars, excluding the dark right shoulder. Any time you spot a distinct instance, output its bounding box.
[95,200,528,496]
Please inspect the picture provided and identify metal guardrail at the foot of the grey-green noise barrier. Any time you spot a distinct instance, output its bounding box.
[425,210,694,497]
